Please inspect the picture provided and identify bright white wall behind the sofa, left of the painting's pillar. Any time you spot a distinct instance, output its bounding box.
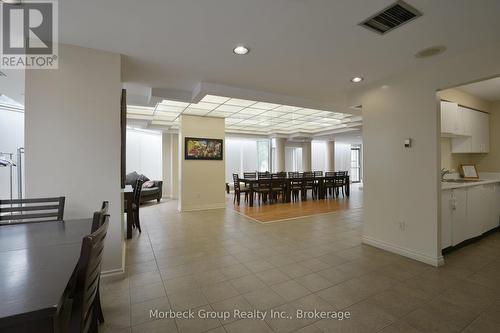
[127,129,163,180]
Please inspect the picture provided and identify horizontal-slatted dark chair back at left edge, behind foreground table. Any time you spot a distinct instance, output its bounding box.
[0,197,66,224]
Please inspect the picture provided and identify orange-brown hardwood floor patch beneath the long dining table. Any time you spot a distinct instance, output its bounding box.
[227,184,363,223]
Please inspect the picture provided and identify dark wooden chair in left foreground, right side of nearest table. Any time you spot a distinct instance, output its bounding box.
[57,215,109,333]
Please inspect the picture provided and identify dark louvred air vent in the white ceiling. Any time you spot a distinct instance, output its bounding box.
[360,1,422,35]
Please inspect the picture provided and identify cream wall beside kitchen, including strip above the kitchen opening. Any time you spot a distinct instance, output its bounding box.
[356,45,500,265]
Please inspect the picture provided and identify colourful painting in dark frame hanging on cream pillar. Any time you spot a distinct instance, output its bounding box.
[184,137,224,161]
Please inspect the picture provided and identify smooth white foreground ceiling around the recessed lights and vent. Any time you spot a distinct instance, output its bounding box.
[59,0,500,104]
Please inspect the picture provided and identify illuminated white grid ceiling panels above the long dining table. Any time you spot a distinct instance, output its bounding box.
[127,95,361,135]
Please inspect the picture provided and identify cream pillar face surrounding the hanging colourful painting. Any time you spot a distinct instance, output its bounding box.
[178,115,226,211]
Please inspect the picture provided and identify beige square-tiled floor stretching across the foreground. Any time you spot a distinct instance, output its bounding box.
[100,198,500,333]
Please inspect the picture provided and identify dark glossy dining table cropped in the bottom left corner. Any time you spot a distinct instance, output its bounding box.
[0,219,92,333]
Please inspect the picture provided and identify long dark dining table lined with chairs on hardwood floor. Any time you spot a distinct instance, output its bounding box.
[239,175,351,207]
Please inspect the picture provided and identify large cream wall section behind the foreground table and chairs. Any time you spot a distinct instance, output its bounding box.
[25,45,124,271]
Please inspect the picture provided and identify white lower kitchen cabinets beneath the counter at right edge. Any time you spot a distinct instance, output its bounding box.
[441,183,500,249]
